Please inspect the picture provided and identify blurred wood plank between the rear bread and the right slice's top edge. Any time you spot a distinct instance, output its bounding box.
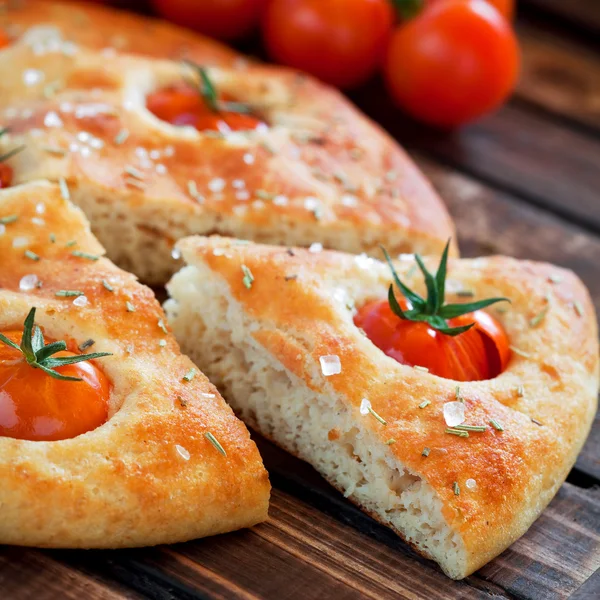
[416,156,600,481]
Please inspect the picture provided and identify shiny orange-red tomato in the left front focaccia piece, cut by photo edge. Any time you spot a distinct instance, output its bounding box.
[0,331,110,440]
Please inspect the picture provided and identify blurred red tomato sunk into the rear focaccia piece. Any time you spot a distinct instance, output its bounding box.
[146,85,263,132]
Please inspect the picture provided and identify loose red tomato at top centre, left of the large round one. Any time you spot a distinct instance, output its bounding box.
[263,0,394,88]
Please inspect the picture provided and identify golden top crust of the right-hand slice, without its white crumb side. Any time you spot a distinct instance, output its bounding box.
[178,237,598,576]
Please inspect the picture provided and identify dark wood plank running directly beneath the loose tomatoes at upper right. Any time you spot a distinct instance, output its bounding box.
[353,85,600,231]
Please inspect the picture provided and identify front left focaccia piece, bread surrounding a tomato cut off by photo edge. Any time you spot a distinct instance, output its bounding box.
[0,183,270,548]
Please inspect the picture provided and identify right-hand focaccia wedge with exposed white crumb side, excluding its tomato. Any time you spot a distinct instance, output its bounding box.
[166,237,598,578]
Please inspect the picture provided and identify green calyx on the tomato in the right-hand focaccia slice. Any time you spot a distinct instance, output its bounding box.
[382,240,510,337]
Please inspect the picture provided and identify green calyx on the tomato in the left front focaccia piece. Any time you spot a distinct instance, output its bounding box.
[0,307,112,381]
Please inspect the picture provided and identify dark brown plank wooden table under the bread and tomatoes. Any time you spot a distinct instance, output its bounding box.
[0,0,600,600]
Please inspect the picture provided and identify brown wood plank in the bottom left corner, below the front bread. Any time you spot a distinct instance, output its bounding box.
[0,546,141,600]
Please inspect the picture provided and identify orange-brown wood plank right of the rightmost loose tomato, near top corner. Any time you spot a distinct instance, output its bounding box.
[516,25,600,131]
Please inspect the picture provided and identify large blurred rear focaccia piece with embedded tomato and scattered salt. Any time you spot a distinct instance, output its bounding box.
[0,1,453,284]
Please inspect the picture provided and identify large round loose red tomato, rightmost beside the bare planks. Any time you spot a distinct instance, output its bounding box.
[385,0,520,127]
